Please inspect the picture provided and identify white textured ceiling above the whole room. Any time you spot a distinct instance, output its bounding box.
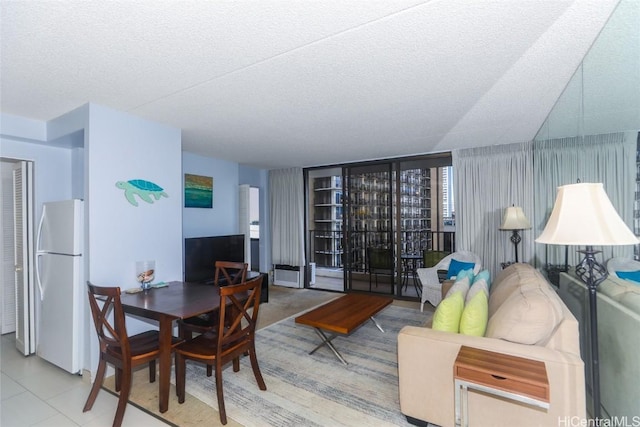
[0,0,638,168]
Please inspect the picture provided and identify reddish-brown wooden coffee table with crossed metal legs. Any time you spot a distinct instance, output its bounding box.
[296,294,393,365]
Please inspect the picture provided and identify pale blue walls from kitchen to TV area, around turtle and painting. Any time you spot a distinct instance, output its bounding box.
[0,108,271,380]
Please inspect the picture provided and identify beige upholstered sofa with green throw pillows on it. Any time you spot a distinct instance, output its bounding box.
[398,264,586,426]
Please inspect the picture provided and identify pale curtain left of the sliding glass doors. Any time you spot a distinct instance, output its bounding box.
[269,168,305,267]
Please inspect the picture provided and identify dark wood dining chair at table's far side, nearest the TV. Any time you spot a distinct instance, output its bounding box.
[178,261,249,342]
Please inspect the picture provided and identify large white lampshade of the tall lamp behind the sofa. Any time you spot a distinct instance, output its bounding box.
[536,182,639,246]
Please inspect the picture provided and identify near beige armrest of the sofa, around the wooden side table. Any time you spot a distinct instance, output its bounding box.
[398,326,586,426]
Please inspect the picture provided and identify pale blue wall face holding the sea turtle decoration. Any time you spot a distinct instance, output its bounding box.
[85,104,182,289]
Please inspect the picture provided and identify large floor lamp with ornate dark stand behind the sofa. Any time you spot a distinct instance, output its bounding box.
[536,183,638,420]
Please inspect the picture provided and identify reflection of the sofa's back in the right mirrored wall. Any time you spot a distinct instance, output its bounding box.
[558,271,640,423]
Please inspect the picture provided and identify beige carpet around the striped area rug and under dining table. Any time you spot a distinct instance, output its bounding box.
[104,286,419,427]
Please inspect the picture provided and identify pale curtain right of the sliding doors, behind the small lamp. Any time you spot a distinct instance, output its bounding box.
[452,142,534,277]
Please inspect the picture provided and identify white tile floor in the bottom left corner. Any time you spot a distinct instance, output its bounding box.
[0,334,167,427]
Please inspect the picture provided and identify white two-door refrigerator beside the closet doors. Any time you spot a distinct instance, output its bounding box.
[36,199,86,373]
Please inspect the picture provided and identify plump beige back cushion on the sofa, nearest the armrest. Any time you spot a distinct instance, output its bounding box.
[486,279,563,345]
